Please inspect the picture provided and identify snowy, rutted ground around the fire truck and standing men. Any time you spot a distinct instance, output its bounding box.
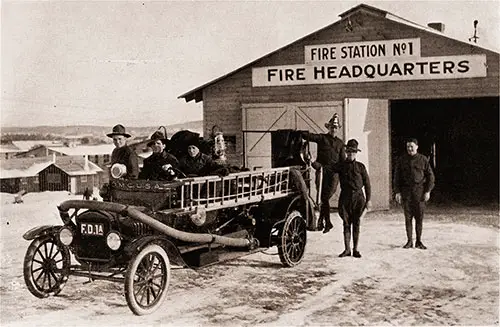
[0,192,500,326]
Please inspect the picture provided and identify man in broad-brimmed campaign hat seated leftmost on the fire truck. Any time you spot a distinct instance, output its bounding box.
[106,124,139,179]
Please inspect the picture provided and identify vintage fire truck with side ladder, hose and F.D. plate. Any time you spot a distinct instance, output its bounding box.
[23,131,318,315]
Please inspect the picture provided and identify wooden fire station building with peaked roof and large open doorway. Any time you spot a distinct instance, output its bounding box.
[180,4,500,209]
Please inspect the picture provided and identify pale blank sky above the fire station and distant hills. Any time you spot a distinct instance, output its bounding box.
[0,0,500,127]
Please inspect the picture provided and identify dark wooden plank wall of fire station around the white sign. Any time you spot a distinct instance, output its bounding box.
[203,12,500,164]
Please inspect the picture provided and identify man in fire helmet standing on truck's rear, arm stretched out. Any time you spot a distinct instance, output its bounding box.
[302,113,345,233]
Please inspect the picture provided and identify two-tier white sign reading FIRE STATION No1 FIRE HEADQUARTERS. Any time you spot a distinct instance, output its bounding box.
[252,39,487,87]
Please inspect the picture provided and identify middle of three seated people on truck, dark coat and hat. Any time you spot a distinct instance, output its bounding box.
[139,130,179,181]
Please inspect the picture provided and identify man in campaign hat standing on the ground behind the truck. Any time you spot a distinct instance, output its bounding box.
[334,139,371,258]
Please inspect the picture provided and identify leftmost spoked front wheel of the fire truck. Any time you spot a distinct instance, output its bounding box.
[23,236,71,298]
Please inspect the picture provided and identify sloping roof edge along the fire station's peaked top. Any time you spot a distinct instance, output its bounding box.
[177,4,498,102]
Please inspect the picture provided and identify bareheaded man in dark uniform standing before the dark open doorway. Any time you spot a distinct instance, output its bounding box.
[393,138,434,250]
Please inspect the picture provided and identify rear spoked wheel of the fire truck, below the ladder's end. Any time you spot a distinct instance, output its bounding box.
[278,210,307,267]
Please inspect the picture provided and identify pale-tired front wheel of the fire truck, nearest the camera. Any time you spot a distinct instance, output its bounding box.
[125,244,170,316]
